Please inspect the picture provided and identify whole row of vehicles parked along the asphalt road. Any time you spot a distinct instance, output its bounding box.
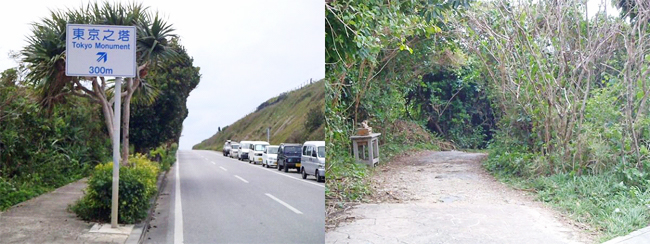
[223,140,325,182]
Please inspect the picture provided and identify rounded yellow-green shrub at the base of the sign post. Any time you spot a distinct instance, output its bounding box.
[71,155,160,224]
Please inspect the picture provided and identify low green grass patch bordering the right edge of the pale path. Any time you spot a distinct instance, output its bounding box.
[488,166,650,242]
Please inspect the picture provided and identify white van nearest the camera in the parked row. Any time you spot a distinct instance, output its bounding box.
[300,141,325,182]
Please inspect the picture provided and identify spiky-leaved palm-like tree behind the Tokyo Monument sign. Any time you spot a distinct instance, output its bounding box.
[21,2,178,164]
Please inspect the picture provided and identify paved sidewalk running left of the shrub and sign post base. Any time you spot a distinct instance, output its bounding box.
[0,179,129,243]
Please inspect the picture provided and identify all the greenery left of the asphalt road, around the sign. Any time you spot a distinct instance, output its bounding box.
[0,0,200,223]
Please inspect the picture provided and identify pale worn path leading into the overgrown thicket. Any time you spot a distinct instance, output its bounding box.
[325,151,593,243]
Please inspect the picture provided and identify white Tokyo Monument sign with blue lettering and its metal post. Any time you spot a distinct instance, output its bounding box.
[65,24,136,228]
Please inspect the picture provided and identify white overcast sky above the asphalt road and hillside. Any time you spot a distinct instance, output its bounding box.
[0,0,325,149]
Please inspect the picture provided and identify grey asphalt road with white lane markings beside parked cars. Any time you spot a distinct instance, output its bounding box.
[146,150,325,243]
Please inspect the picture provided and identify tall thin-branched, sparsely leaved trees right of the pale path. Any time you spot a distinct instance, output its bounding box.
[457,0,650,173]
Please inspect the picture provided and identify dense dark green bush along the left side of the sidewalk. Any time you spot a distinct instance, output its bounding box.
[0,81,110,210]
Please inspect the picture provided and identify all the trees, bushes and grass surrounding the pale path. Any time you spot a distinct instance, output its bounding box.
[325,0,650,240]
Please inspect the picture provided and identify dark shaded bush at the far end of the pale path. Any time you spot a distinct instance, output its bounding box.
[406,65,495,148]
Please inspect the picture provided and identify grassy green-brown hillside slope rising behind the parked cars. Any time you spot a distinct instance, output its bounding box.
[192,80,325,151]
